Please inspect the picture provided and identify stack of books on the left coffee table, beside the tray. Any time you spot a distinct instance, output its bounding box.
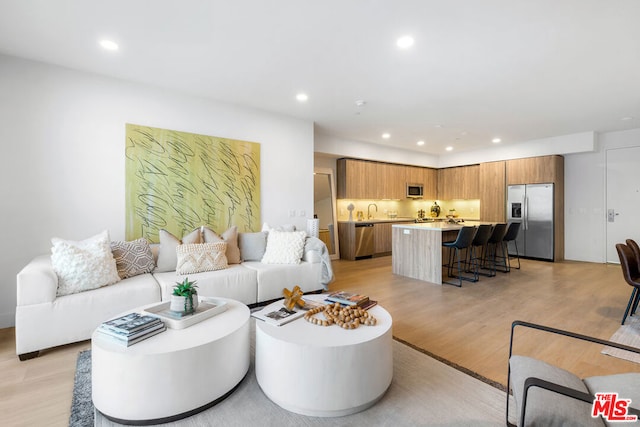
[98,313,167,347]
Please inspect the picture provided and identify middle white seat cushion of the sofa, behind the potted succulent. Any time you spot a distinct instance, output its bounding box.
[153,264,258,304]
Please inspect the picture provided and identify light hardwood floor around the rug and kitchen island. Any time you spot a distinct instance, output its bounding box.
[0,257,640,426]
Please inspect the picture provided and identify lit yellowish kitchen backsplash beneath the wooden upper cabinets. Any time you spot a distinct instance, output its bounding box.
[337,199,481,221]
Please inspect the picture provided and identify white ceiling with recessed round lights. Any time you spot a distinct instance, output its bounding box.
[0,0,640,155]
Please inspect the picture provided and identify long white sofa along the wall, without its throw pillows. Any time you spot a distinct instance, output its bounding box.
[16,229,333,360]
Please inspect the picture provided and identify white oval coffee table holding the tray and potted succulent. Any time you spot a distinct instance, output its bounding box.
[91,298,250,425]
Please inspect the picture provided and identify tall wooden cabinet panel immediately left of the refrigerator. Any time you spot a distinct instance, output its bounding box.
[479,161,506,222]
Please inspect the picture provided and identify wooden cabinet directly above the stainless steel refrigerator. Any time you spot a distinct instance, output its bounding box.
[507,156,564,185]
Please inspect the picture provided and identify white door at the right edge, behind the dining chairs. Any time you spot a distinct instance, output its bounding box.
[606,147,640,263]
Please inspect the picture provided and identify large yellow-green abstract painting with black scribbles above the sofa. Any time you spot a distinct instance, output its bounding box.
[125,124,260,242]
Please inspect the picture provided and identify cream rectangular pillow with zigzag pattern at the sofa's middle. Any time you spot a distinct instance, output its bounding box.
[176,242,228,274]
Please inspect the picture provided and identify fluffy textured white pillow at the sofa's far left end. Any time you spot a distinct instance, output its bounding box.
[51,230,120,296]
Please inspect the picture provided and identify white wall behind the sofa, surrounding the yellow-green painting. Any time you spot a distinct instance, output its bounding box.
[0,55,313,328]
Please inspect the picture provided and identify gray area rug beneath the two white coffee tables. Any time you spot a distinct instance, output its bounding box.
[69,322,505,427]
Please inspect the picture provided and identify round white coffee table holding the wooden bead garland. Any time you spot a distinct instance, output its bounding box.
[255,295,393,417]
